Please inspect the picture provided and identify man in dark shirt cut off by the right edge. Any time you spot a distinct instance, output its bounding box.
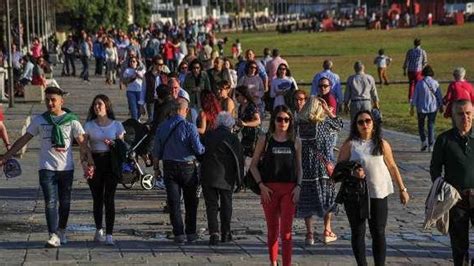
[430,100,474,265]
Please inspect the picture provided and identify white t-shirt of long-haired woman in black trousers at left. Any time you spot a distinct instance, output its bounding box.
[84,120,125,152]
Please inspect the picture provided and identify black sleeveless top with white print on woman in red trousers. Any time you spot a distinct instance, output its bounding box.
[261,137,296,183]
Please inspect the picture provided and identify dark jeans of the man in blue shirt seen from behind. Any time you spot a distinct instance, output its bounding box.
[163,161,199,236]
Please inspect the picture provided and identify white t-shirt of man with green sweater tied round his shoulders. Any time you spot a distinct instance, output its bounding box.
[26,113,84,171]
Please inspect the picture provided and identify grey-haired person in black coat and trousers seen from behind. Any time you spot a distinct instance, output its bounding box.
[201,112,244,245]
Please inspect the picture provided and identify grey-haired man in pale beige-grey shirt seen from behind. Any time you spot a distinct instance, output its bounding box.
[344,61,379,121]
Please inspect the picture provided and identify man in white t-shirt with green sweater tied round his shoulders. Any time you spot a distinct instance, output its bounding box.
[0,87,94,247]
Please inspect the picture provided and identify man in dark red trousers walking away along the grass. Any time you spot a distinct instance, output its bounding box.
[403,38,428,101]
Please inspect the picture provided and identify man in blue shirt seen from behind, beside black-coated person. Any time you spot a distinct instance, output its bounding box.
[153,98,204,244]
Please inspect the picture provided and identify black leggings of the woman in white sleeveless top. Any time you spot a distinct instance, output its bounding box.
[344,197,388,266]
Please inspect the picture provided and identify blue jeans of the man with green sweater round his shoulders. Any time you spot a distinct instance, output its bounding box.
[39,169,74,233]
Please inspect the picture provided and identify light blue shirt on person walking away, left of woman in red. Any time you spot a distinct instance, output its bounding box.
[410,76,442,114]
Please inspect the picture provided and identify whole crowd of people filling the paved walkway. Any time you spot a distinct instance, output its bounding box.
[0,21,474,265]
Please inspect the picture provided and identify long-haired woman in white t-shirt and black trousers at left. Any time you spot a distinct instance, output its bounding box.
[84,94,125,245]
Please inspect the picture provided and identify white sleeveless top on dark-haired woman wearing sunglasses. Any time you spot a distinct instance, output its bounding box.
[350,140,393,199]
